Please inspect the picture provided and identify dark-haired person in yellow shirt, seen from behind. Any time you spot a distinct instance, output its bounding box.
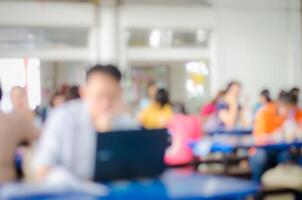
[139,89,172,129]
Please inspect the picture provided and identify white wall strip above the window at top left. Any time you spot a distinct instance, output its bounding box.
[0,0,94,27]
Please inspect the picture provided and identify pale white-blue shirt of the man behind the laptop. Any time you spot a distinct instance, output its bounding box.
[34,100,138,179]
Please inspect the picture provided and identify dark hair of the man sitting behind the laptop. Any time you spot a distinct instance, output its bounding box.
[86,64,122,82]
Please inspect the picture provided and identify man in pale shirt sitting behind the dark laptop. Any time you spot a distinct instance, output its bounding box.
[34,65,137,181]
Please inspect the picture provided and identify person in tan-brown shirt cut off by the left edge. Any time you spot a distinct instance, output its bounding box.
[0,84,39,184]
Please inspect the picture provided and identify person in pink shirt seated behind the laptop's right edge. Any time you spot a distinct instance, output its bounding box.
[165,103,202,165]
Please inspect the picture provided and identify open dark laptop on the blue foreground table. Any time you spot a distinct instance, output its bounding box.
[94,129,171,182]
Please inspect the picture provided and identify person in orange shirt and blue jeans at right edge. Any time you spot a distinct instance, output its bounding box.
[250,92,302,181]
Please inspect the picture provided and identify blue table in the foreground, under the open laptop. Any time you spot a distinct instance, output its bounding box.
[1,170,260,200]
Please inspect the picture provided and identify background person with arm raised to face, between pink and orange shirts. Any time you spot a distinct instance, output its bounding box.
[216,81,249,130]
